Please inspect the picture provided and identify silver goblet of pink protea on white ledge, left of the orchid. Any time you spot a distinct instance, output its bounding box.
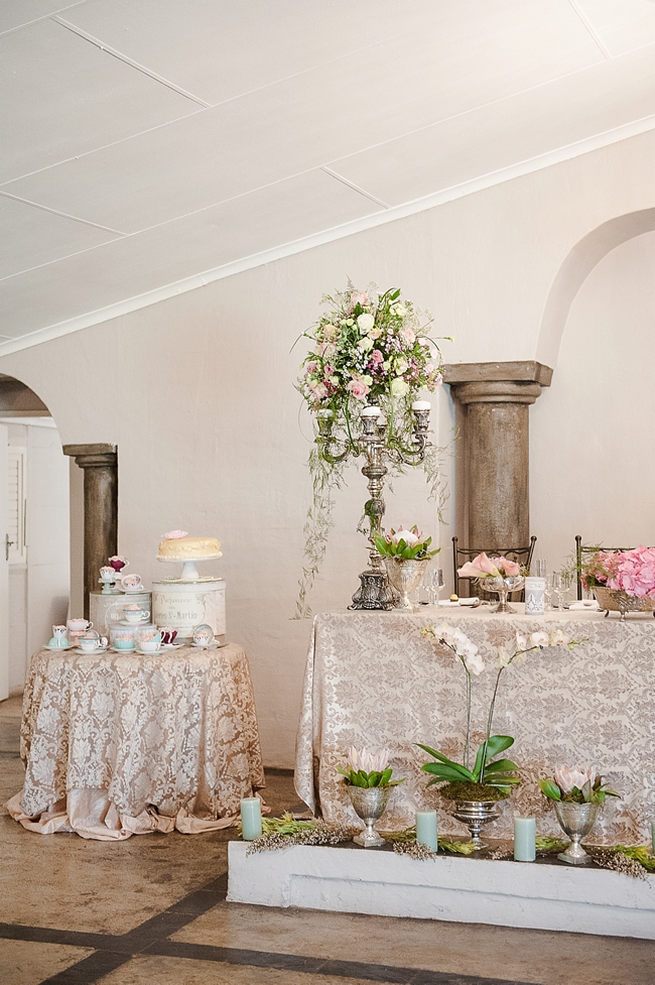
[337,746,403,848]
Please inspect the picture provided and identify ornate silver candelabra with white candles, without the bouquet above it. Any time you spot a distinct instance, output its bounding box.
[316,400,431,609]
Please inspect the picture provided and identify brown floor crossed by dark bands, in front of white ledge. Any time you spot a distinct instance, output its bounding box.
[0,699,655,985]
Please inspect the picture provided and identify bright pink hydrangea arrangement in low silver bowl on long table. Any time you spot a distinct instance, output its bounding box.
[580,547,655,618]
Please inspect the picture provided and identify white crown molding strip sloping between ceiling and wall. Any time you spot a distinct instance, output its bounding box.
[0,116,655,357]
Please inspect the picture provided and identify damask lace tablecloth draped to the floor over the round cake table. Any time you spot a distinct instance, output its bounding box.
[7,643,264,839]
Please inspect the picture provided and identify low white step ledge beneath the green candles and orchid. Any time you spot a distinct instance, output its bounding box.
[227,841,655,940]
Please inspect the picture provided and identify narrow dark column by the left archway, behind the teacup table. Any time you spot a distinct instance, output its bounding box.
[63,444,118,618]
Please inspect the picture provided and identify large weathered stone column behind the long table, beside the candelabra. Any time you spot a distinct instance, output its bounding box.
[444,362,553,549]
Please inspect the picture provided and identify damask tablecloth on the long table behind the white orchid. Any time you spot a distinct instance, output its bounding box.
[295,604,655,844]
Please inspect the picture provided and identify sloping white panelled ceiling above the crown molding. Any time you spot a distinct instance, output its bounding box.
[0,0,655,354]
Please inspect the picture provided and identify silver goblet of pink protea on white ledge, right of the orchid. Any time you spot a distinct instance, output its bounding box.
[539,766,620,865]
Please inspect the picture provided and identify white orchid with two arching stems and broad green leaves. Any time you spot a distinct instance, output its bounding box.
[417,623,580,800]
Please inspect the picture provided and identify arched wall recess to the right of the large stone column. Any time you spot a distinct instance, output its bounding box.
[530,209,655,568]
